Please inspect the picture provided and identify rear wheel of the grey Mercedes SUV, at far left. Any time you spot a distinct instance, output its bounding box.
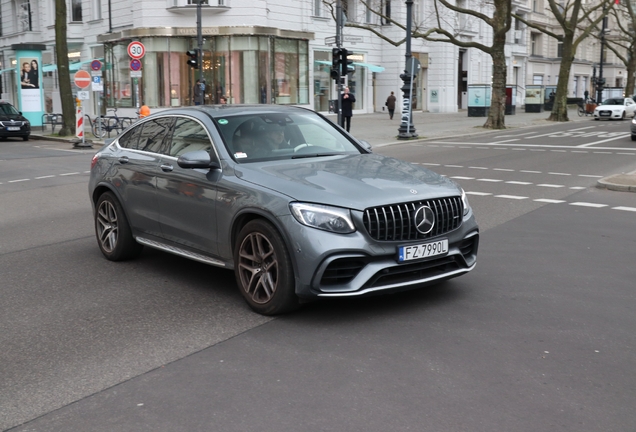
[95,192,143,261]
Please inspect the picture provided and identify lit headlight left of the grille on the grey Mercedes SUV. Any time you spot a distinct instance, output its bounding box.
[289,202,356,234]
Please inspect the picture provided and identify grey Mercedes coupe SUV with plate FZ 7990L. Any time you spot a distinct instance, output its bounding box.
[89,105,479,315]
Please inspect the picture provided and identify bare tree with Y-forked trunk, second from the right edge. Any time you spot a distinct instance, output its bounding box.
[512,0,609,122]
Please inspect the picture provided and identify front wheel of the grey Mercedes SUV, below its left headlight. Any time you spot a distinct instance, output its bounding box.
[234,219,299,315]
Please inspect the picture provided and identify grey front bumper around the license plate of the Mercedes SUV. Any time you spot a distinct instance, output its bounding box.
[285,211,479,298]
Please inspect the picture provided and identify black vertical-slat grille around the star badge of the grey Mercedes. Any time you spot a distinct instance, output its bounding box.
[363,197,464,241]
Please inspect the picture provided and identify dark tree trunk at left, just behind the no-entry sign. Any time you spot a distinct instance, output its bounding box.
[55,0,75,136]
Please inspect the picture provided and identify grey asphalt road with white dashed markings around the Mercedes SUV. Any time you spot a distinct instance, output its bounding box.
[0,122,636,432]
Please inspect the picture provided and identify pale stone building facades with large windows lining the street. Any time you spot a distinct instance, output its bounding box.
[0,0,625,121]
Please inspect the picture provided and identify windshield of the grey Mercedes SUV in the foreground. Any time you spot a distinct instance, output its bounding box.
[215,112,361,163]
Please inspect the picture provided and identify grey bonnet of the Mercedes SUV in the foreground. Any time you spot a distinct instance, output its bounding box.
[235,154,461,210]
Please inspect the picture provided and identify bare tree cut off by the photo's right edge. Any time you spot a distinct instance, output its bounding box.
[599,1,636,96]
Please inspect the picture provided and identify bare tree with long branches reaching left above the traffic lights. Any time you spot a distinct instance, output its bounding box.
[323,0,512,129]
